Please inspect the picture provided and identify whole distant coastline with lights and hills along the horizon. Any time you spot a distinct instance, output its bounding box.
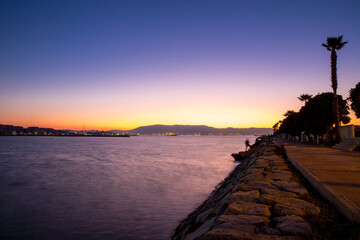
[0,124,273,137]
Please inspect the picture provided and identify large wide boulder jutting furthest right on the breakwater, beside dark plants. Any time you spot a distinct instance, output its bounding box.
[273,198,320,216]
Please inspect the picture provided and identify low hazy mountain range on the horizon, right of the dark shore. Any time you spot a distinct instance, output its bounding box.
[109,125,273,135]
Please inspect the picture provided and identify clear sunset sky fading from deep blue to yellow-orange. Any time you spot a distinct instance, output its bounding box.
[0,0,360,130]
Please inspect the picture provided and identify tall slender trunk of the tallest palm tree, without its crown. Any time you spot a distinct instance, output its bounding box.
[331,49,341,142]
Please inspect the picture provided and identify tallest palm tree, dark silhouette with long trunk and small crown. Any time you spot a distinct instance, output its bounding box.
[322,36,348,142]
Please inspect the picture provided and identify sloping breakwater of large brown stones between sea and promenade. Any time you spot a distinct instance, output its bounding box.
[171,143,320,240]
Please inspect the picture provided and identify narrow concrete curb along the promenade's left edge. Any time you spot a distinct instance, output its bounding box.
[275,143,360,223]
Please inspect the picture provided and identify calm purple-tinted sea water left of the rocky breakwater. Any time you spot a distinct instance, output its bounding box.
[0,136,255,239]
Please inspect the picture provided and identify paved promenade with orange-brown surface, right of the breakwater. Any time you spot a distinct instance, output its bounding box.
[274,138,360,223]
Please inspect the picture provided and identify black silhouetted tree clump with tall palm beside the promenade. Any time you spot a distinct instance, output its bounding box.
[273,36,360,143]
